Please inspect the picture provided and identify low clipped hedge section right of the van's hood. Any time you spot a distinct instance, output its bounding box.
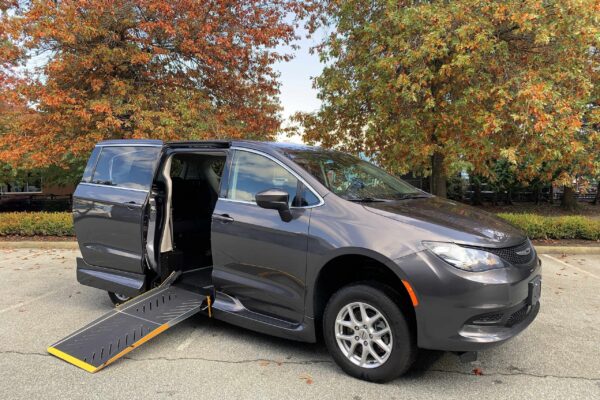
[498,213,600,240]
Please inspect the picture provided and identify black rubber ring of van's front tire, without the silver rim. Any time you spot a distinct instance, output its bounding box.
[323,284,416,382]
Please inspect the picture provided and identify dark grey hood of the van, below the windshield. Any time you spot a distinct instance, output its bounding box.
[365,196,526,247]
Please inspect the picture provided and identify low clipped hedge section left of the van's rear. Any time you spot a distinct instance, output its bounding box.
[0,212,75,236]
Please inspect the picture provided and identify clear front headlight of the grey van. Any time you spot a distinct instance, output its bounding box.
[423,242,505,272]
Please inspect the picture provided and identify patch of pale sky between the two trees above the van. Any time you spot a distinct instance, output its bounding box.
[274,26,323,143]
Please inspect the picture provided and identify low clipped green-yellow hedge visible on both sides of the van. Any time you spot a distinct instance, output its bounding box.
[0,212,600,240]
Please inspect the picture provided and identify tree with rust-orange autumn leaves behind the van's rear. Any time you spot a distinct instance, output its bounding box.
[0,0,310,170]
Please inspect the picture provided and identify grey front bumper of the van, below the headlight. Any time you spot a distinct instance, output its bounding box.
[396,251,541,352]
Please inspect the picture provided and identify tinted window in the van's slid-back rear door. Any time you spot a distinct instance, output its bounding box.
[91,146,160,190]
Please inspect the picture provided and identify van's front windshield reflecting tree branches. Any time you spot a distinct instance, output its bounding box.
[287,150,428,201]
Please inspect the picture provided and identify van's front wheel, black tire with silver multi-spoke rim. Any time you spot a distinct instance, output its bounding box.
[323,282,417,382]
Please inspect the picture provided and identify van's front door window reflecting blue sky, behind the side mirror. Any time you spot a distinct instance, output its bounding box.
[227,151,318,206]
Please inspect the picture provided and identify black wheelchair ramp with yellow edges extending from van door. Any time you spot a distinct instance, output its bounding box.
[48,273,212,373]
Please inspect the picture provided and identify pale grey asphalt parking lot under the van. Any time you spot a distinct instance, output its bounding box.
[0,249,600,400]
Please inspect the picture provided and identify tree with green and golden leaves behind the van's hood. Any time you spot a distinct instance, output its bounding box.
[295,0,600,196]
